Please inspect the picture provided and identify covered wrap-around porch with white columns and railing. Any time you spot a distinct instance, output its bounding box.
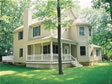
[26,39,76,62]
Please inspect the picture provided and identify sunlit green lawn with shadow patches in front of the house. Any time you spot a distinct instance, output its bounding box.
[0,63,112,84]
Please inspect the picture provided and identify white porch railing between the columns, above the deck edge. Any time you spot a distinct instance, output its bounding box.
[26,54,71,61]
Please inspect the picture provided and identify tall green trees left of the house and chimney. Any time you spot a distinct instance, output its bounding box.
[0,0,31,60]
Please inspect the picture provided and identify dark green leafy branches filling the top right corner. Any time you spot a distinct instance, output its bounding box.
[92,0,112,24]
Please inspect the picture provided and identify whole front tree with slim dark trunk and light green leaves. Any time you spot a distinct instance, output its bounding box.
[34,0,78,74]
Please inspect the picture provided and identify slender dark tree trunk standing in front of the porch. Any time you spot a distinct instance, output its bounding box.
[57,0,63,75]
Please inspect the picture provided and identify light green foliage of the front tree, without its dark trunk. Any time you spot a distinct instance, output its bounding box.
[34,0,79,29]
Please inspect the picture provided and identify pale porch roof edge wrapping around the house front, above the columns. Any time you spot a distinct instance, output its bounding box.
[27,36,77,45]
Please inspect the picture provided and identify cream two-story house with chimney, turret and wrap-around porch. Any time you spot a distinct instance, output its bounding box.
[14,10,102,68]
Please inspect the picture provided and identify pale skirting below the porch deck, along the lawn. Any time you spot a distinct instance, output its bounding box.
[26,62,72,69]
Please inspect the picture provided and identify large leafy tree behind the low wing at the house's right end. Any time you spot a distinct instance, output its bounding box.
[79,8,112,59]
